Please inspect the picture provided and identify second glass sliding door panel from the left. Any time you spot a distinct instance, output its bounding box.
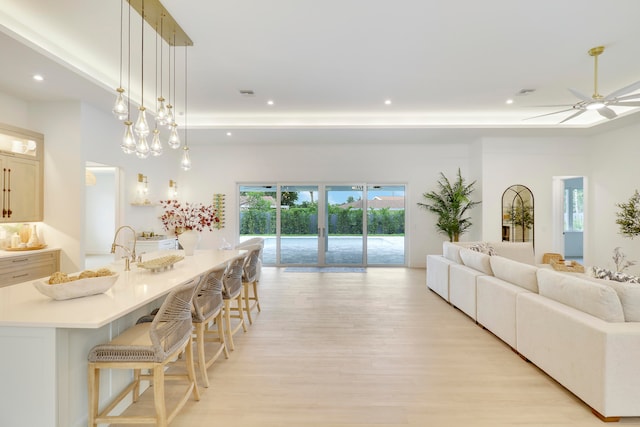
[278,185,320,265]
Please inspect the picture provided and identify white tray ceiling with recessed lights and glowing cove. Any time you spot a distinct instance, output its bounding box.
[0,0,640,131]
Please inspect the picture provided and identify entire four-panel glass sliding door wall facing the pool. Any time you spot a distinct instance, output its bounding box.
[238,184,405,266]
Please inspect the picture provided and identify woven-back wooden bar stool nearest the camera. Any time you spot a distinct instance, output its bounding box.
[88,279,200,427]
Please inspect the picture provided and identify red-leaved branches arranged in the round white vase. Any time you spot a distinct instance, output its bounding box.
[160,200,220,234]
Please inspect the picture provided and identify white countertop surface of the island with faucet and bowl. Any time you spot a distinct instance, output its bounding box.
[0,250,246,329]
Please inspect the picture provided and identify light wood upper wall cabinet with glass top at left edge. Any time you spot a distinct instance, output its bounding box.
[0,124,44,223]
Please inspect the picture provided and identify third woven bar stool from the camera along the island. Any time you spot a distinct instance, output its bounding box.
[222,254,247,350]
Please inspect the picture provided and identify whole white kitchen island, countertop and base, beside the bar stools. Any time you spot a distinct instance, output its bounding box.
[0,250,246,427]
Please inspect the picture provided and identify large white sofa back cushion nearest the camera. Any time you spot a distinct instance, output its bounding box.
[537,268,625,322]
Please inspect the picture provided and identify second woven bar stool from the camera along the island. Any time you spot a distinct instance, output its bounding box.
[192,265,229,387]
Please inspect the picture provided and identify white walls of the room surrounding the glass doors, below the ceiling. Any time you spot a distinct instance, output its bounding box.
[5,88,640,272]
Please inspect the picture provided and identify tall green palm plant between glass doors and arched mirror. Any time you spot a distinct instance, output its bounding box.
[418,168,481,242]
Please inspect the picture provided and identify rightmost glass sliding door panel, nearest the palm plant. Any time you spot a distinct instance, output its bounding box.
[367,185,405,265]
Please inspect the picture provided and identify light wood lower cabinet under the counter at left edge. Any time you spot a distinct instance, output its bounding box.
[0,249,60,287]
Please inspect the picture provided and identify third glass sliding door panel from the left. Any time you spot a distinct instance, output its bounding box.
[321,185,364,265]
